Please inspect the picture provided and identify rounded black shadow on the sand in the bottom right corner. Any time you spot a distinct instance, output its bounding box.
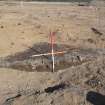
[86,91,105,105]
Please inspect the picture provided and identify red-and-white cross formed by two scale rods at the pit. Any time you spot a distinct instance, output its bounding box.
[32,32,67,72]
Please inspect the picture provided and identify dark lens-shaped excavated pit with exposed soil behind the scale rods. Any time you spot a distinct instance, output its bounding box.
[0,43,105,72]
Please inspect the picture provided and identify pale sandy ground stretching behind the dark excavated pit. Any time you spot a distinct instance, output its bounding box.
[0,1,105,56]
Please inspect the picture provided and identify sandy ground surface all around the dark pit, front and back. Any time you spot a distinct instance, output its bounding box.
[0,3,105,105]
